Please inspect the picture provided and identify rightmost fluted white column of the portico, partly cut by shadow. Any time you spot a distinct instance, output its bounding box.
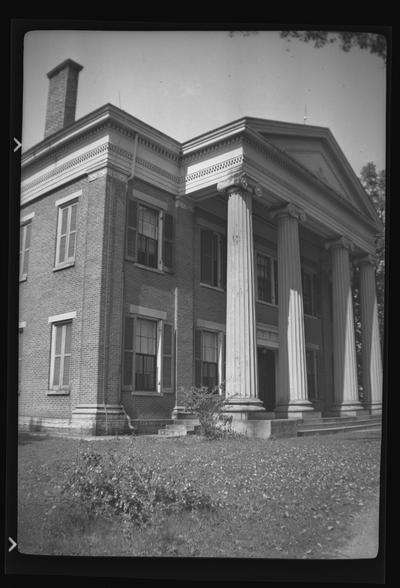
[358,255,382,413]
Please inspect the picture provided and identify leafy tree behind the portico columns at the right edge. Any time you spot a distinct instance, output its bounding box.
[353,161,386,395]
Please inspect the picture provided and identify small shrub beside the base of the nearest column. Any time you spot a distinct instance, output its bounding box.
[183,385,236,439]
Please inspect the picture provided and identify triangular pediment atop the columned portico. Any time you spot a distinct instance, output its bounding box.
[247,119,379,229]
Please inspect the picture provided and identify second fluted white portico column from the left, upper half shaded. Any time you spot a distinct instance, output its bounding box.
[271,204,313,418]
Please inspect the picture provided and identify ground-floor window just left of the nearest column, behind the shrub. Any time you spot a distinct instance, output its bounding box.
[195,329,225,390]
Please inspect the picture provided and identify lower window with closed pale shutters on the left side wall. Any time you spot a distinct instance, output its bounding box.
[50,321,72,390]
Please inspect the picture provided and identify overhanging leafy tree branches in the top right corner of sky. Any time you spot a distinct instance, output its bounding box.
[281,31,386,63]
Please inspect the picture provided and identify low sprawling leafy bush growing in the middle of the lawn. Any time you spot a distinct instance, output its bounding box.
[62,450,218,524]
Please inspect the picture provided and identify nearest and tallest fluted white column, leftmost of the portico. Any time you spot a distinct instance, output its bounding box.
[218,175,264,413]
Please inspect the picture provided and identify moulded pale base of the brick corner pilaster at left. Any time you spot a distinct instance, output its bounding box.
[71,404,129,435]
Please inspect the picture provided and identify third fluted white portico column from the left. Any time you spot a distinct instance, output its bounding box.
[325,237,362,415]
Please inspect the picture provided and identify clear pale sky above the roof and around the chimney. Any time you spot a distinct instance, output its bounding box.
[22,31,386,175]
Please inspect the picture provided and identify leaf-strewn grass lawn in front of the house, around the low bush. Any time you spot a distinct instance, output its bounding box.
[18,433,380,558]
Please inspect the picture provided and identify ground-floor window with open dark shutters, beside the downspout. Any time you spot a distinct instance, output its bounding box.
[122,316,173,393]
